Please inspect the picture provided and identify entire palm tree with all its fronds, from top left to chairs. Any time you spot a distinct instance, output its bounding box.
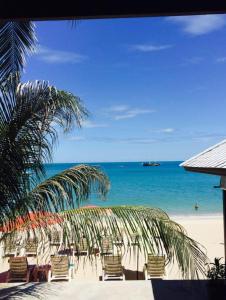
[0,22,206,278]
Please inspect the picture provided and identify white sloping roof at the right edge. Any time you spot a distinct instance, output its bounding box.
[180,140,226,169]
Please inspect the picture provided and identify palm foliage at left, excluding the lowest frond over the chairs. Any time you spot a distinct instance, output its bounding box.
[0,22,109,226]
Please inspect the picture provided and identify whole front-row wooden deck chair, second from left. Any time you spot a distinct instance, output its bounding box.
[48,255,73,282]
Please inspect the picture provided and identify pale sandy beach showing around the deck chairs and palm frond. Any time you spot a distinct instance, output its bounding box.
[1,215,224,281]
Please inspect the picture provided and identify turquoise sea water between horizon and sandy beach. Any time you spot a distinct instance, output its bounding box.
[46,161,222,215]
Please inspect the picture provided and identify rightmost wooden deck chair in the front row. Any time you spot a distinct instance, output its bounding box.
[144,254,165,280]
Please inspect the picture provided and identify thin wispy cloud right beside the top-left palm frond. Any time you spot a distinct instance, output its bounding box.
[35,46,87,64]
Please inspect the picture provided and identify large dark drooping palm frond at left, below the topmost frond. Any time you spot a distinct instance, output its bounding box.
[0,76,88,225]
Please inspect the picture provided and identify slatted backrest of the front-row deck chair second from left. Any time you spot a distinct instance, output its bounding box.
[50,256,69,276]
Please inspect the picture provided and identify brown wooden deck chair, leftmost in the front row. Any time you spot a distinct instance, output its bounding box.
[7,256,30,282]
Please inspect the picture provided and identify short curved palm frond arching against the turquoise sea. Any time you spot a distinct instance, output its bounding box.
[28,165,110,212]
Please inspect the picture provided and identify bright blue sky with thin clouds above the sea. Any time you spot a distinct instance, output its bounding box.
[22,15,226,163]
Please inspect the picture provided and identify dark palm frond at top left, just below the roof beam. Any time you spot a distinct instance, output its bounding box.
[0,21,36,82]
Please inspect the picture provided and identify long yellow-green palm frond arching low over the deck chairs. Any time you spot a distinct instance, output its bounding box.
[59,206,207,279]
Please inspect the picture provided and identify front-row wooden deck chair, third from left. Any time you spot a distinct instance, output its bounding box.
[102,255,125,281]
